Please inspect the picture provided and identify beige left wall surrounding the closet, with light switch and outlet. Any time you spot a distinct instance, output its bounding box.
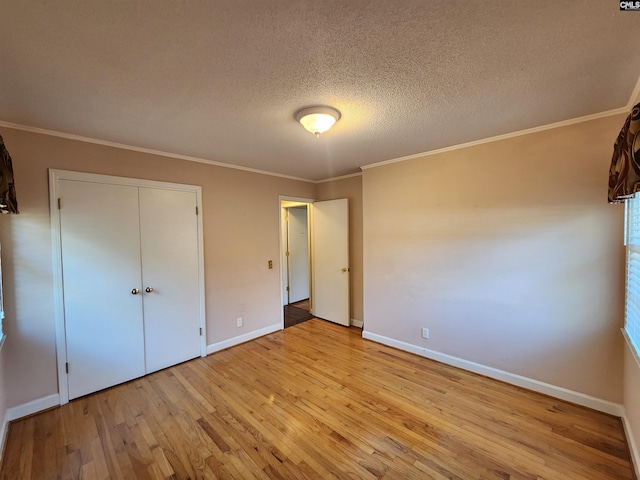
[0,128,315,407]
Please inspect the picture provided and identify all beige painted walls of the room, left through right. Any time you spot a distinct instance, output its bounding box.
[0,112,640,446]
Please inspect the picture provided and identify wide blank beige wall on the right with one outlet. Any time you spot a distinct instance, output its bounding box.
[363,116,624,403]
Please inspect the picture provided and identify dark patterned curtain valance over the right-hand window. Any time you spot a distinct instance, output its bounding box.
[609,103,640,203]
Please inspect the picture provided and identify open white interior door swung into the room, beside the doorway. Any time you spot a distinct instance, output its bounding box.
[312,198,350,326]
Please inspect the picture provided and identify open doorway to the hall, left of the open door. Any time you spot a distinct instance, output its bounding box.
[281,200,313,328]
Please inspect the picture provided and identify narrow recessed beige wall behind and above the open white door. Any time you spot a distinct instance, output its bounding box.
[316,176,364,321]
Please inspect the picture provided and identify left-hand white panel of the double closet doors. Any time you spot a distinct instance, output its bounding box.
[60,180,145,399]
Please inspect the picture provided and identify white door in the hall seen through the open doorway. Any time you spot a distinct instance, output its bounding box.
[288,205,309,303]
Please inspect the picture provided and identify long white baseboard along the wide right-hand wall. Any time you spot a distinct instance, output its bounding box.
[362,330,624,417]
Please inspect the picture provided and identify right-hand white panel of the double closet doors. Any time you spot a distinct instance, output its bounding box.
[140,188,200,373]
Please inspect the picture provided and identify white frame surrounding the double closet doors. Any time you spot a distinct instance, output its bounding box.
[49,169,205,405]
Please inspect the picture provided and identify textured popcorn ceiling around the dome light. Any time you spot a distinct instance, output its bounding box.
[0,0,640,180]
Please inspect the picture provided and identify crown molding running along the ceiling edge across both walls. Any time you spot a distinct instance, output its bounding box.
[0,78,640,184]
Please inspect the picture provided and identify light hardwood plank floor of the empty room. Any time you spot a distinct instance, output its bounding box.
[0,320,634,480]
